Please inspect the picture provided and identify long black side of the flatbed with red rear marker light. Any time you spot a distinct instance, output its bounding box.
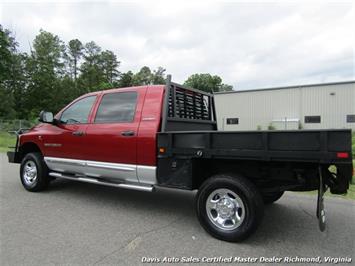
[158,129,352,164]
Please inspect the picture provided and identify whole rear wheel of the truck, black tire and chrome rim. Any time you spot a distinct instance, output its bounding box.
[196,175,264,242]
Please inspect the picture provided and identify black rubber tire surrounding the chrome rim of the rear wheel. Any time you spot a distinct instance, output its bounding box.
[196,175,264,242]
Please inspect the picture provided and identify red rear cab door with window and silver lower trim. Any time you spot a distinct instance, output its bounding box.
[85,88,146,182]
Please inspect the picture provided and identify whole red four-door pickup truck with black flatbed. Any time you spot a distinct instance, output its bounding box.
[8,77,353,242]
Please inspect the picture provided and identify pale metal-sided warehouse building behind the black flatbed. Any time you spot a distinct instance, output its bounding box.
[215,81,355,131]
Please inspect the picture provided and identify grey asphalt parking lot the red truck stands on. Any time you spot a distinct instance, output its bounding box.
[0,154,355,265]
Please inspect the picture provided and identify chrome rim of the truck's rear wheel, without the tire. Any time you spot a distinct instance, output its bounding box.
[206,188,245,230]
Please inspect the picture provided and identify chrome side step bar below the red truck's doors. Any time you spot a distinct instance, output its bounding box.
[49,172,154,192]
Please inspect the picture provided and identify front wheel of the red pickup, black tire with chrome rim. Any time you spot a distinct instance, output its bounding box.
[20,152,50,192]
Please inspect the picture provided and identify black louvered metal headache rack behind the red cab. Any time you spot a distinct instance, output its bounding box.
[162,75,217,132]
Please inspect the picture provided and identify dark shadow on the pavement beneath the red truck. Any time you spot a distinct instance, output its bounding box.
[48,180,330,246]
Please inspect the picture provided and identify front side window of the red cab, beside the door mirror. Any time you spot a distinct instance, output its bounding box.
[60,96,96,124]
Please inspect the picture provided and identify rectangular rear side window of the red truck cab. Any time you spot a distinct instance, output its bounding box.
[95,91,137,123]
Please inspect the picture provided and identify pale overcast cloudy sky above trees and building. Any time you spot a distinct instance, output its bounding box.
[0,1,355,89]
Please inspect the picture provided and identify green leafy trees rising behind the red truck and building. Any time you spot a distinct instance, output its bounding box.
[0,25,233,120]
